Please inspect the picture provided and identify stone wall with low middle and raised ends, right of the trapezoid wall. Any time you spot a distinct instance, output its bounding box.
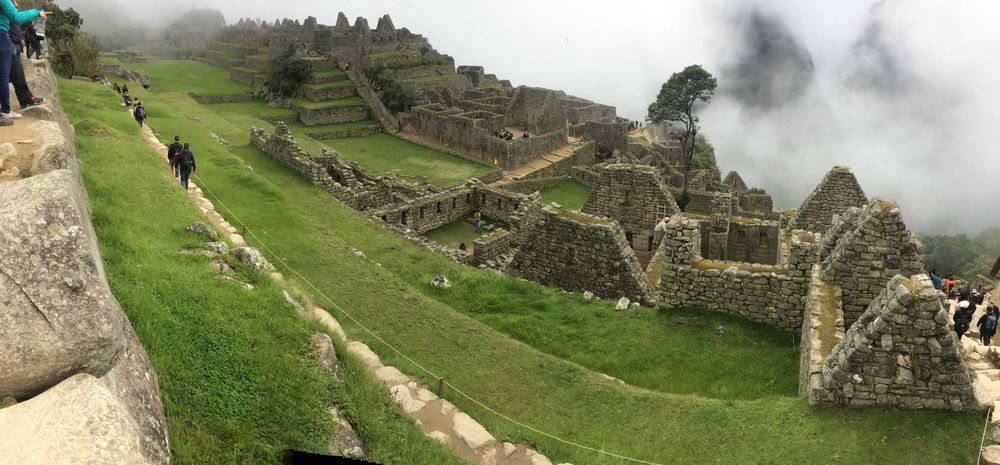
[658,216,817,331]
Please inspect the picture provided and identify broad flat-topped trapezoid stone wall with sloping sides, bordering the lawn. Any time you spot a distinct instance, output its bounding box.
[508,205,650,302]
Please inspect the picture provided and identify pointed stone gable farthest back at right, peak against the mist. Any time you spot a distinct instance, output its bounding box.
[791,166,867,233]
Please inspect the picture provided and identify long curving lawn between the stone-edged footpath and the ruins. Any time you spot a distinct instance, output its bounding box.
[117,62,982,465]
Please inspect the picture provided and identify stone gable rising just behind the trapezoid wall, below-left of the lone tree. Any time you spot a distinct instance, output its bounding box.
[583,164,680,266]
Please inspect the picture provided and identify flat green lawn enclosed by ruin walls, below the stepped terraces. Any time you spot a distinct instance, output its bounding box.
[323,134,494,186]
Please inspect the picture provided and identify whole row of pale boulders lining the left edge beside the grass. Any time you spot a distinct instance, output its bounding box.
[0,53,170,464]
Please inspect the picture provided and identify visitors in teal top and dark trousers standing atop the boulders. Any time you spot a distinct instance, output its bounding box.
[0,0,48,126]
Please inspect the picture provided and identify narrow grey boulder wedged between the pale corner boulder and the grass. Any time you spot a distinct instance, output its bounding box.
[101,325,170,463]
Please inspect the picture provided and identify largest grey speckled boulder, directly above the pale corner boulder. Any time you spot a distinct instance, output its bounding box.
[0,170,128,400]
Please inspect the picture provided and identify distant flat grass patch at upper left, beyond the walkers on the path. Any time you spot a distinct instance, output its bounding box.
[128,60,253,95]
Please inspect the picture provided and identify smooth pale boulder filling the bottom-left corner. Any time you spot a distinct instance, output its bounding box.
[0,373,150,465]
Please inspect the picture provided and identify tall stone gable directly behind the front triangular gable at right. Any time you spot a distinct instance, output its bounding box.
[822,199,924,328]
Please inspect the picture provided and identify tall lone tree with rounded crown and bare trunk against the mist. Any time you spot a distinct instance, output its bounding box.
[646,65,717,190]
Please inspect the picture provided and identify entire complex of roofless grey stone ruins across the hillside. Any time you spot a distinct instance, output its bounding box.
[166,14,992,410]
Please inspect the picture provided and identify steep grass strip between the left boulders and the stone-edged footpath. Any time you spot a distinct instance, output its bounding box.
[59,80,465,465]
